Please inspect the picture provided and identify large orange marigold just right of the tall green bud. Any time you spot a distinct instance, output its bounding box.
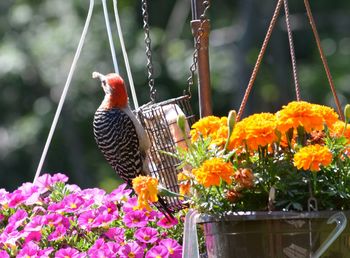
[229,113,277,150]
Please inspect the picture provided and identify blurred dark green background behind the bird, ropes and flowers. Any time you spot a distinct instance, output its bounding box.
[0,0,350,190]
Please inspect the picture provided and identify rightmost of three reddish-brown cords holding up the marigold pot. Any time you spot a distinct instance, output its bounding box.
[304,0,344,120]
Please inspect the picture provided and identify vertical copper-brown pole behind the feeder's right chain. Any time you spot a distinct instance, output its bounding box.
[191,0,213,117]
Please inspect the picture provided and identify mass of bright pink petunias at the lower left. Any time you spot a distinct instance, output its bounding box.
[0,174,182,258]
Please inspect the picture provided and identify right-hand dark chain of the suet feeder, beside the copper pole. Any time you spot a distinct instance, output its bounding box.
[184,1,210,97]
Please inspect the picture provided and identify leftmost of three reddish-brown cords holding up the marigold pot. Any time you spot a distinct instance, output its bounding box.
[236,0,283,121]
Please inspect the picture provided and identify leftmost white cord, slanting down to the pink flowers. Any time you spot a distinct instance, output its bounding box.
[33,0,94,183]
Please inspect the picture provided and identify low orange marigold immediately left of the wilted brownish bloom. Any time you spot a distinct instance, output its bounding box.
[192,158,234,187]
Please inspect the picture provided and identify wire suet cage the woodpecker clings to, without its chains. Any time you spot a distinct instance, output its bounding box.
[136,95,195,211]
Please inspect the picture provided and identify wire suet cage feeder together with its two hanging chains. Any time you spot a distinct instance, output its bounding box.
[135,0,209,211]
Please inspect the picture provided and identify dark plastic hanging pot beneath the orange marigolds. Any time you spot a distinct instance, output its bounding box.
[198,211,350,258]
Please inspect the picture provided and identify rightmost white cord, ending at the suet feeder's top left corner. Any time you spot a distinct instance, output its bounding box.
[113,0,139,109]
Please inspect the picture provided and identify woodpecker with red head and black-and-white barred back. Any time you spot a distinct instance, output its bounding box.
[92,72,171,216]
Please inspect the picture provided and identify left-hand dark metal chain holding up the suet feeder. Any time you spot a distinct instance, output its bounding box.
[141,0,157,103]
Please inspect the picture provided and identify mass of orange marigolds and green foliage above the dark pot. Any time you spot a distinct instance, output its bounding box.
[172,101,350,214]
